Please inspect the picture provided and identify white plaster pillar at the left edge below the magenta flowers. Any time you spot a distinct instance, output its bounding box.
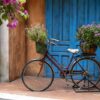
[0,21,9,82]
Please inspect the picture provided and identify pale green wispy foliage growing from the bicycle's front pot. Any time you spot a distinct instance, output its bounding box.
[26,24,47,44]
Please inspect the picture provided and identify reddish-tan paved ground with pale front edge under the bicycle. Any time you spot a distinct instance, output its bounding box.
[0,79,100,100]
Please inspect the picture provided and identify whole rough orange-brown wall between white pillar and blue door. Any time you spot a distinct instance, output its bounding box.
[9,0,45,81]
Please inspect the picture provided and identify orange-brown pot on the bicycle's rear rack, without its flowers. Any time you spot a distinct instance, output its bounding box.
[80,42,97,54]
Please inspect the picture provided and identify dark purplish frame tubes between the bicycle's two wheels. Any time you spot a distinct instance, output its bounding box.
[42,51,77,72]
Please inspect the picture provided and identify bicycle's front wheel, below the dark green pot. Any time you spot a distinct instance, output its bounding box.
[22,60,54,91]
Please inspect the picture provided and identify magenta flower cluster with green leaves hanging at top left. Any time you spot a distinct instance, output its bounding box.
[0,0,29,28]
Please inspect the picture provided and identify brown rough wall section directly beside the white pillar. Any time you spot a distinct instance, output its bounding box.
[9,22,25,80]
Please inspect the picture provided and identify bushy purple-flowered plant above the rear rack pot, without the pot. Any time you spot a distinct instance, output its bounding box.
[76,24,100,48]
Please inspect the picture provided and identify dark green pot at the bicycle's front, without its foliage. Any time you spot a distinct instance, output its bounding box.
[36,42,47,54]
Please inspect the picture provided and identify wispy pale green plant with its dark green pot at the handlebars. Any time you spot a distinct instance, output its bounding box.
[26,24,47,54]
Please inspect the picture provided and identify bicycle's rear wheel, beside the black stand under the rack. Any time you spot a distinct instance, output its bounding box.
[71,57,100,89]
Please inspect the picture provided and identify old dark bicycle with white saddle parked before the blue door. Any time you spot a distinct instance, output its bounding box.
[21,39,100,91]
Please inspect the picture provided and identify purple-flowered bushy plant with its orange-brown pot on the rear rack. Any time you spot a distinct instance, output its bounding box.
[77,24,100,53]
